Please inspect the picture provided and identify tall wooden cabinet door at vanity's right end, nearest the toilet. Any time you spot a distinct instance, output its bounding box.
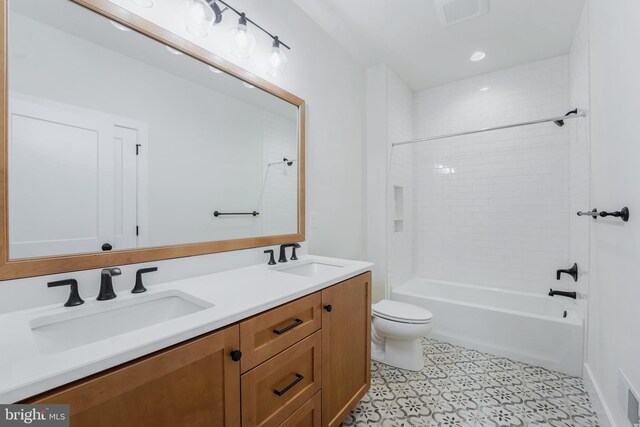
[322,272,371,426]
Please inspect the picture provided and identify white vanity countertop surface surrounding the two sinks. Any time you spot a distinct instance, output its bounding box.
[0,255,373,403]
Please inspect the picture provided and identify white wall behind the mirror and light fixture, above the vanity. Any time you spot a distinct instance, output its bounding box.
[0,0,364,310]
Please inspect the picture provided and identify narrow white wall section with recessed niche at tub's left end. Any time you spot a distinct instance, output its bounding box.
[366,64,413,301]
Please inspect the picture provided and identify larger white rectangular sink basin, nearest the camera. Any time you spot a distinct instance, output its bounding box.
[29,291,213,354]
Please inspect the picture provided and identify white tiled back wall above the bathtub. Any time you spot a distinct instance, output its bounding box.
[410,56,574,293]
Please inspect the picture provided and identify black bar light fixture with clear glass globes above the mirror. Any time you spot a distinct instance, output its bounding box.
[182,0,291,76]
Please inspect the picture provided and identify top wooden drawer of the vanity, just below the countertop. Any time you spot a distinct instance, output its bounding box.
[240,292,322,372]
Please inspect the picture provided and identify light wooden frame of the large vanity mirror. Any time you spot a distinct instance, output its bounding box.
[0,0,305,280]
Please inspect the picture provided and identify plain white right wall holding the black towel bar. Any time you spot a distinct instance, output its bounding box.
[587,0,640,427]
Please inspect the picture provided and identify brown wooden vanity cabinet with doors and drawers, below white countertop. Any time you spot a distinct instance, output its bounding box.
[25,273,371,427]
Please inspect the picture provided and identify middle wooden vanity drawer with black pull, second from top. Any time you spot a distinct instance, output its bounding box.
[241,332,322,427]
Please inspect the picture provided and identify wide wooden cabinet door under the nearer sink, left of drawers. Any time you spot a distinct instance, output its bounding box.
[30,326,240,427]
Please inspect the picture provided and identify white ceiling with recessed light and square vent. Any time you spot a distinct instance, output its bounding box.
[295,0,584,90]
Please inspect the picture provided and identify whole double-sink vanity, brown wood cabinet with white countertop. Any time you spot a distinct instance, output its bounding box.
[0,255,371,426]
